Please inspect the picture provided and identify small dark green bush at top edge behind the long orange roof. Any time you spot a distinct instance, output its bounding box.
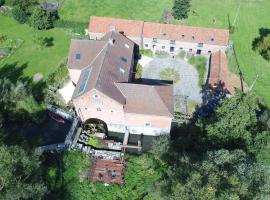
[172,0,190,19]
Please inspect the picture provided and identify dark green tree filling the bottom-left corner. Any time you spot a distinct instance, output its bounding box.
[0,145,46,200]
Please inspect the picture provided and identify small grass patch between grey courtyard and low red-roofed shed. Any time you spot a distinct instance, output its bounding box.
[188,56,207,88]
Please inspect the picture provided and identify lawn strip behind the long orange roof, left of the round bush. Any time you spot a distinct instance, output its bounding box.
[60,0,173,23]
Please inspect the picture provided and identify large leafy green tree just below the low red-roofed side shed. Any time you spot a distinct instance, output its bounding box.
[199,91,266,150]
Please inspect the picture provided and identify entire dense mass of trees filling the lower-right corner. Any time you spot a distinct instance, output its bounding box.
[146,92,270,200]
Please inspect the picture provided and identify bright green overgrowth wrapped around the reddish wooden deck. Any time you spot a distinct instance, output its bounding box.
[44,152,161,200]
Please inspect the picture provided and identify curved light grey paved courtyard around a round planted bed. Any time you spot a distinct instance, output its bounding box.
[142,57,202,103]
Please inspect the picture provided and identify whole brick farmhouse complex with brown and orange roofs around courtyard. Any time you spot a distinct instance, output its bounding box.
[68,16,229,136]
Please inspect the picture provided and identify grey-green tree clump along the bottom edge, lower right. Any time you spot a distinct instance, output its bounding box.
[149,149,270,200]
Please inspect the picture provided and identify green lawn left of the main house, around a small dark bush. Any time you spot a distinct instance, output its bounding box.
[0,16,70,78]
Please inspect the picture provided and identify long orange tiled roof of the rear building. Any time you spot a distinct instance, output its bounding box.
[89,16,229,46]
